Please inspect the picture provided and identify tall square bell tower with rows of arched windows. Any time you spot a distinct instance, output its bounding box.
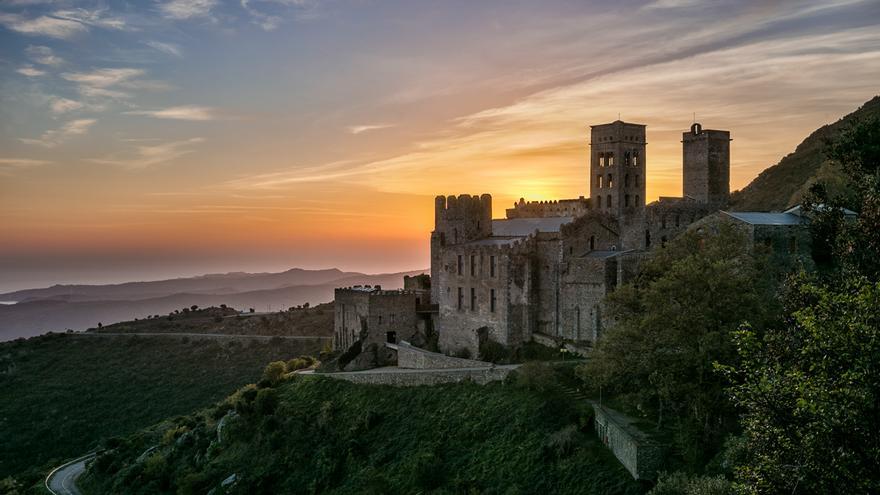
[590,120,647,218]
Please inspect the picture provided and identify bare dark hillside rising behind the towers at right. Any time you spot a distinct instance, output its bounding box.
[730,96,880,211]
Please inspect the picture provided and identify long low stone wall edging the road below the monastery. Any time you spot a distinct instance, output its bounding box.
[312,365,517,387]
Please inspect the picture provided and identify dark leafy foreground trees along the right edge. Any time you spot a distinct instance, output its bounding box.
[722,118,880,493]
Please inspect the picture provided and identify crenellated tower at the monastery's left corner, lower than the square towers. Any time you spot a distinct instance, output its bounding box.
[431,194,492,303]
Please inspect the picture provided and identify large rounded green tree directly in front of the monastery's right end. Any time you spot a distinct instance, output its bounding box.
[581,221,775,465]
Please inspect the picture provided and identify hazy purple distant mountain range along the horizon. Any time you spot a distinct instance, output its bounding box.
[0,268,427,341]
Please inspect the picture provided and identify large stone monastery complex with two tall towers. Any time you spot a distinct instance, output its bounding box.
[336,120,805,356]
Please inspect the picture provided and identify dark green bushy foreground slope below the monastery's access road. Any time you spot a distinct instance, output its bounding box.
[79,370,642,494]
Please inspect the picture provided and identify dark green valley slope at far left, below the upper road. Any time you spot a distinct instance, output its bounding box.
[0,334,320,486]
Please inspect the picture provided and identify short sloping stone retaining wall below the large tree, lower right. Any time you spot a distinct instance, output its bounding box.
[593,404,663,480]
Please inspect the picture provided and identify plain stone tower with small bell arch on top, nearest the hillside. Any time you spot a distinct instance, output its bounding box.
[681,123,730,208]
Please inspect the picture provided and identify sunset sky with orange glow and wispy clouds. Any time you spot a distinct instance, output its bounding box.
[0,0,880,291]
